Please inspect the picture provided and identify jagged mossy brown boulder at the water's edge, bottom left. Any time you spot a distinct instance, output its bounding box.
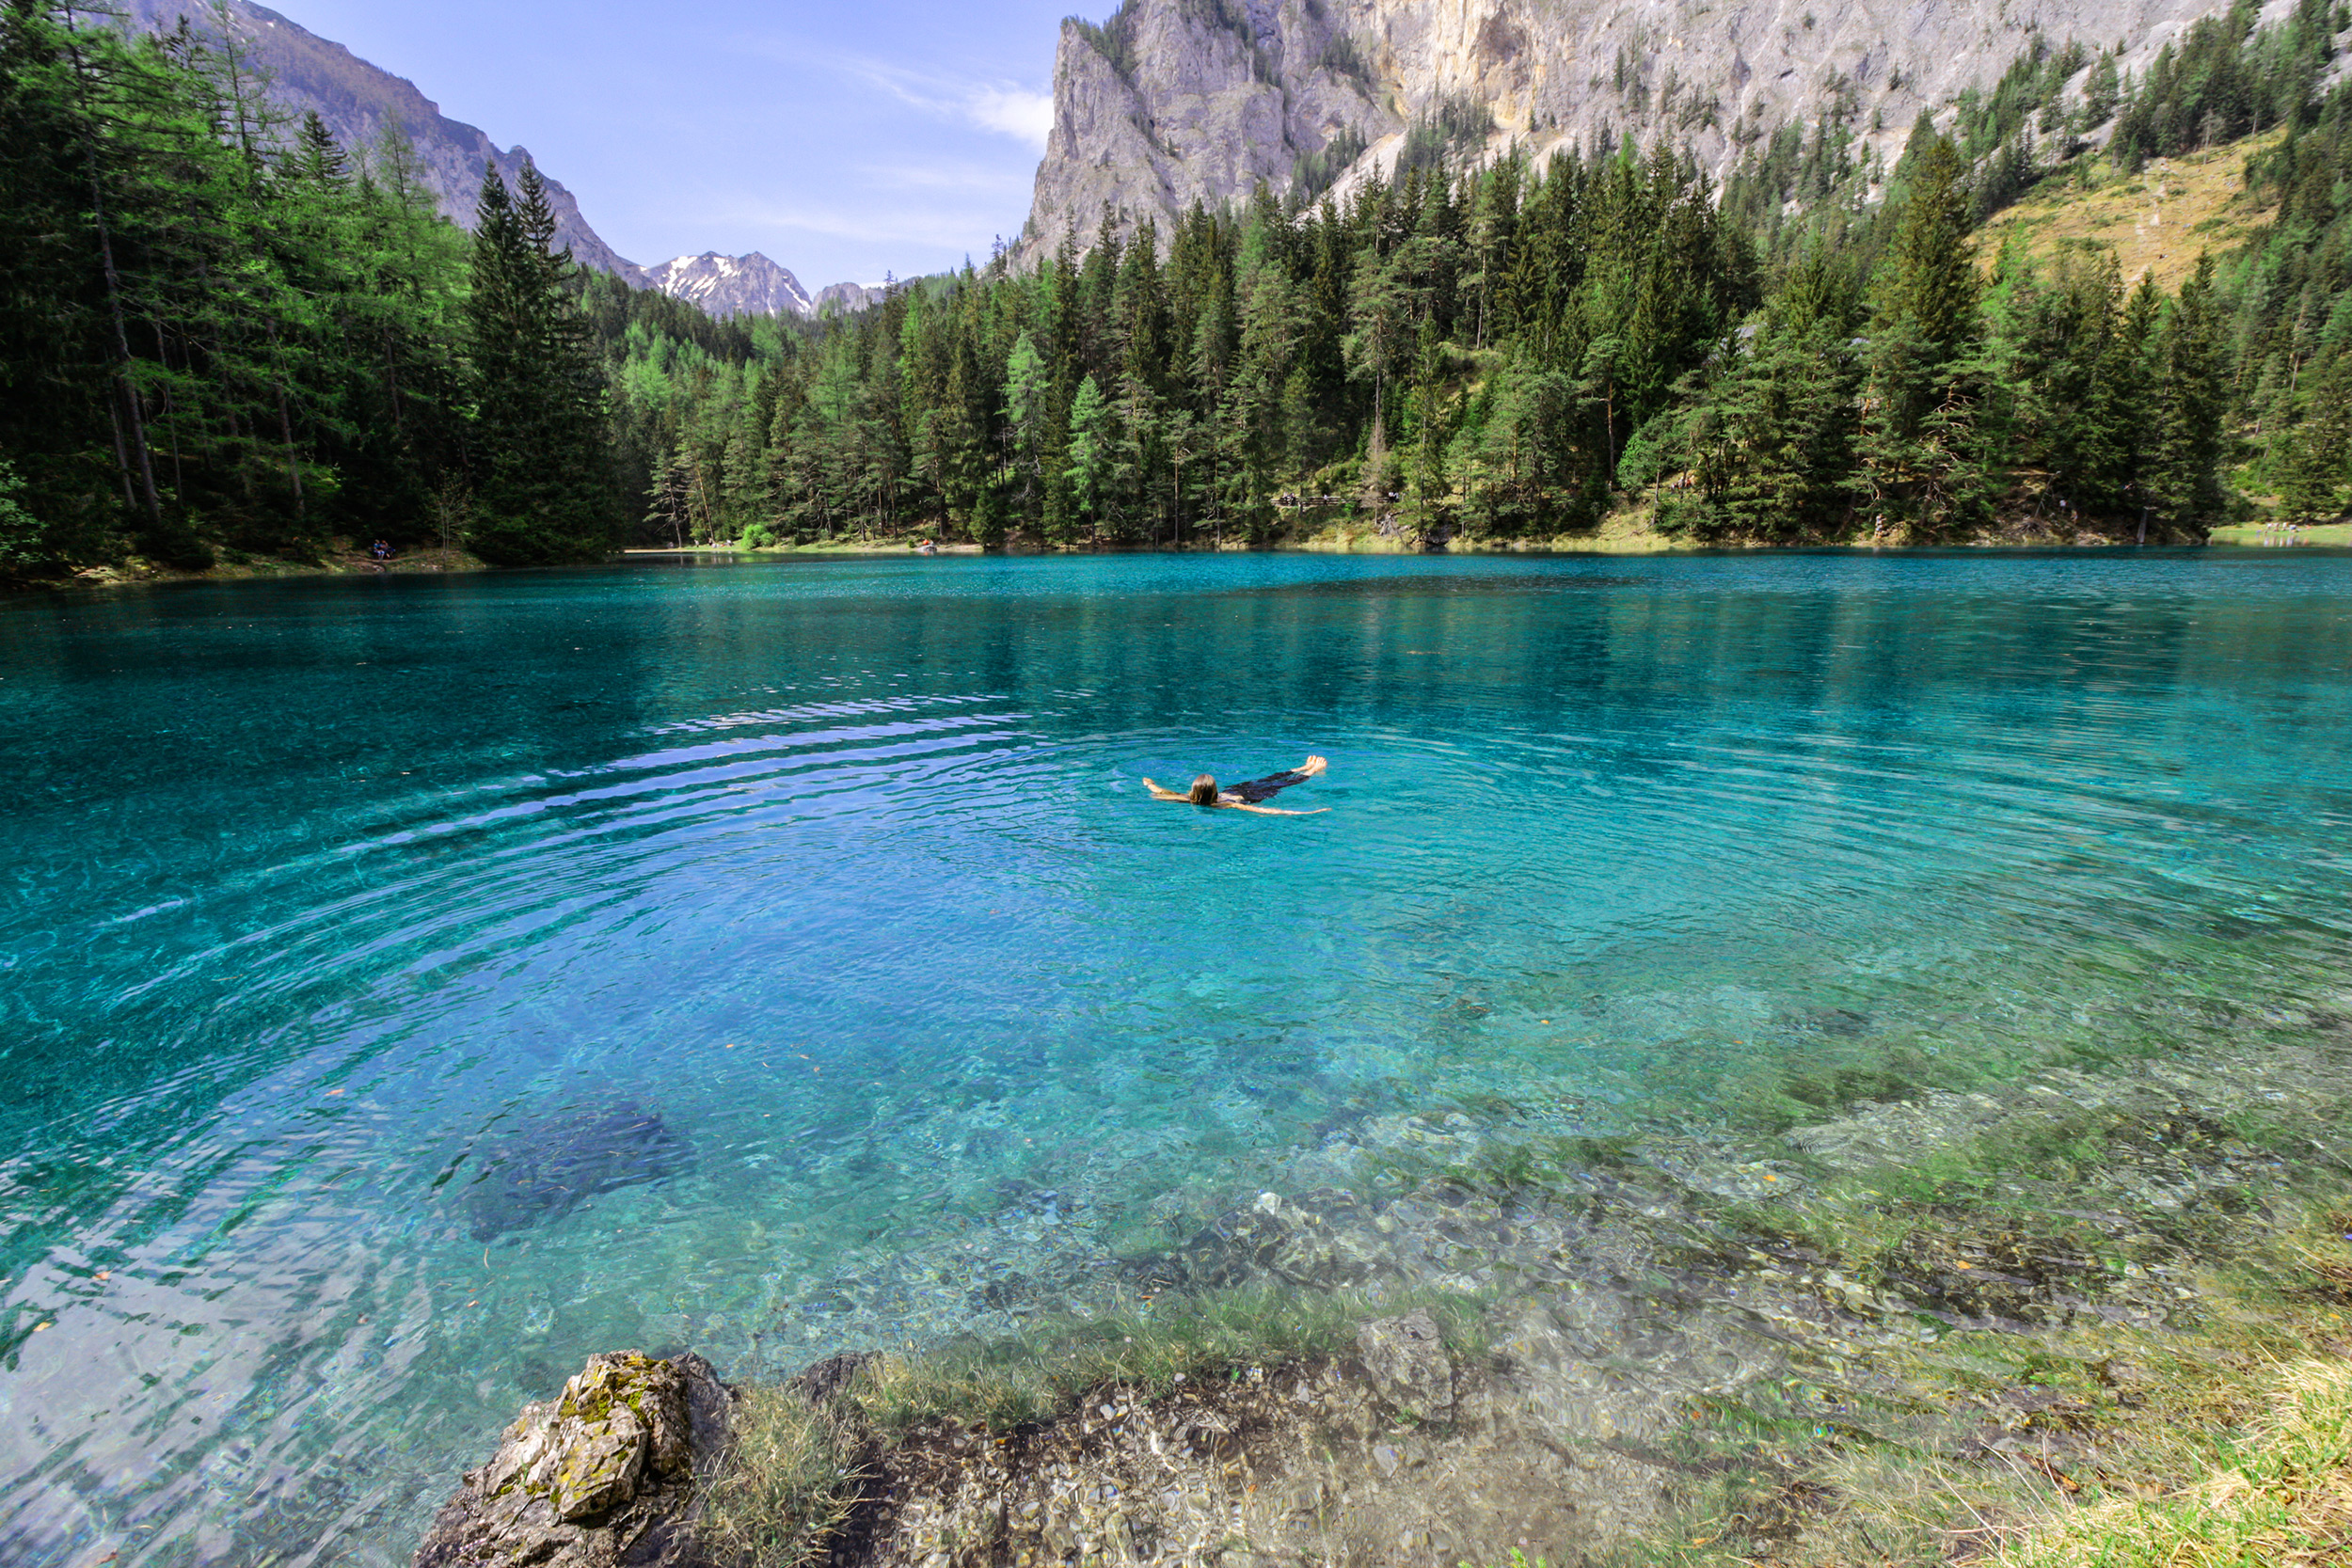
[414,1352,734,1568]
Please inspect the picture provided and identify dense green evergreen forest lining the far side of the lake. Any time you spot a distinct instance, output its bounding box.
[0,0,2352,571]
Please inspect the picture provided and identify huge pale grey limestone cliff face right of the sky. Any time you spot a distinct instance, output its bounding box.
[1024,0,2284,259]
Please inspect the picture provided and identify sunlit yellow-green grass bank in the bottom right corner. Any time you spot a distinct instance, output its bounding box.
[1607,1218,2352,1568]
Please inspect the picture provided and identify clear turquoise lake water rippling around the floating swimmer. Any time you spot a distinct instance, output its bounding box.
[0,552,2352,1566]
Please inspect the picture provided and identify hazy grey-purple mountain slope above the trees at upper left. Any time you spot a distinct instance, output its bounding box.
[127,0,644,287]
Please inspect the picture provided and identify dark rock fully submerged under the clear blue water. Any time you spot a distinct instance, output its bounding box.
[464,1105,694,1242]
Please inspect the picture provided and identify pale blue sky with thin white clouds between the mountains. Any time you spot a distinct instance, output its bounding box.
[279,0,1087,289]
